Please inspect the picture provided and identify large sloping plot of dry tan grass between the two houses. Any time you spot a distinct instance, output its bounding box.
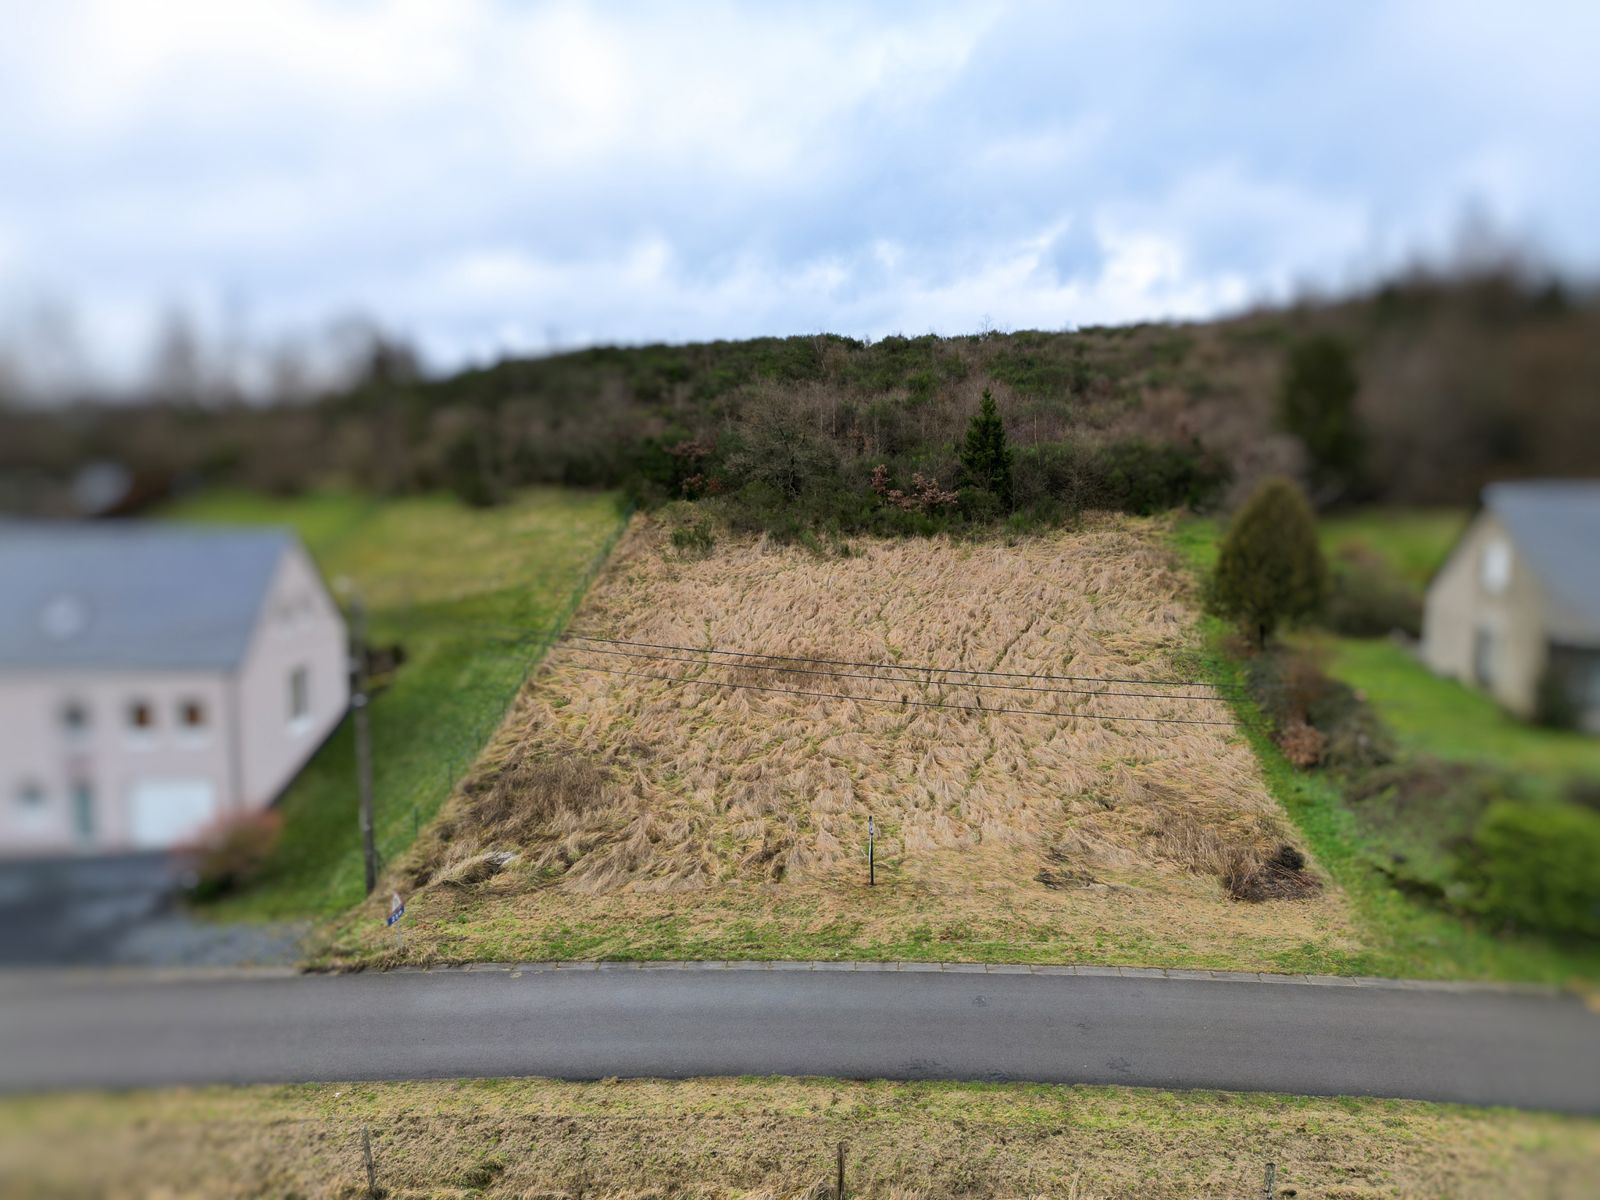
[322,517,1362,971]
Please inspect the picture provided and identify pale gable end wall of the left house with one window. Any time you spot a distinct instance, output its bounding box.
[237,547,350,808]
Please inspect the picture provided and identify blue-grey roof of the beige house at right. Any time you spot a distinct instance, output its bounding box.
[1483,480,1600,642]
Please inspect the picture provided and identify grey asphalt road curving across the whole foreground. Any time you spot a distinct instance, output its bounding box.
[0,963,1600,1114]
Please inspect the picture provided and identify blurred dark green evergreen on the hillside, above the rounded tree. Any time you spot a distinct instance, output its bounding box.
[1278,334,1366,494]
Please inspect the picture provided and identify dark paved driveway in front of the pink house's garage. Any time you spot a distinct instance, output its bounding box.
[0,854,304,966]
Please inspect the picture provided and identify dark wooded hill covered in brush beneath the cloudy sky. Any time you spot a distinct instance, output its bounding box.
[0,270,1600,536]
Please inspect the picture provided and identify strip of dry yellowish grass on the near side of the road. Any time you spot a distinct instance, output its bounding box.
[0,1078,1600,1200]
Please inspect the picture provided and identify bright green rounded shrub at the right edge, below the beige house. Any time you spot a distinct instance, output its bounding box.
[1462,800,1600,938]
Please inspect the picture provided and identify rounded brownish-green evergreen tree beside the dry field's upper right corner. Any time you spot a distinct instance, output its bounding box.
[1210,478,1328,646]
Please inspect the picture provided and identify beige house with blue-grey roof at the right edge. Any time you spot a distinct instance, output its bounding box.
[1422,482,1600,733]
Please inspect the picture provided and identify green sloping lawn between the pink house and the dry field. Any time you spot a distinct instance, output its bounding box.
[170,488,624,918]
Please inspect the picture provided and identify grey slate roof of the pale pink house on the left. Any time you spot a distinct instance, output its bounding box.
[0,522,296,670]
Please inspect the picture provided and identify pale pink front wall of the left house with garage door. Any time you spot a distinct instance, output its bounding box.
[0,670,237,854]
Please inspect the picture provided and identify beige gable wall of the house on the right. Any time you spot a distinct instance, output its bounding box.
[1422,510,1549,717]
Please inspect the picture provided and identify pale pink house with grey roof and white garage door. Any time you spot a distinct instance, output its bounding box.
[0,522,349,854]
